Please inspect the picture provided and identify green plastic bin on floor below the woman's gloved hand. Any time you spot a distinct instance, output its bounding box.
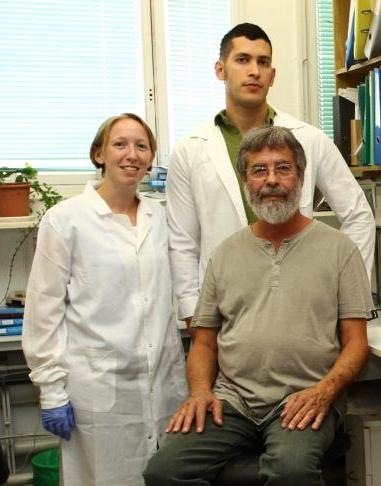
[32,449,60,486]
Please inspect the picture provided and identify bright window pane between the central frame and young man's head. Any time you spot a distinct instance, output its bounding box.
[166,0,230,149]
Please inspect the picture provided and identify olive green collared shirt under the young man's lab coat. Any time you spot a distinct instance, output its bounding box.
[214,106,276,224]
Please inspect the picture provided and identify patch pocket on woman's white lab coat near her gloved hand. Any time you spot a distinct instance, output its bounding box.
[68,348,117,412]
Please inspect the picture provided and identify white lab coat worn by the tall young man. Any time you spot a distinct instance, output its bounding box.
[167,110,375,318]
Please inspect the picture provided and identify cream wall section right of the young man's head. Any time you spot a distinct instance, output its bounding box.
[232,0,318,124]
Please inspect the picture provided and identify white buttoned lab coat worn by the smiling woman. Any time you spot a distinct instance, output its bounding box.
[23,185,187,486]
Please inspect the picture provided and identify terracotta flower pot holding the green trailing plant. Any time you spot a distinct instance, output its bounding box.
[0,182,30,217]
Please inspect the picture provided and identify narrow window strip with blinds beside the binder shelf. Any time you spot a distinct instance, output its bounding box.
[316,0,336,138]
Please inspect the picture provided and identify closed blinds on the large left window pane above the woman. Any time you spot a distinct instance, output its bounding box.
[0,0,145,170]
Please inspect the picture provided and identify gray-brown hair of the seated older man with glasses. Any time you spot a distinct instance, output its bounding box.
[237,126,307,180]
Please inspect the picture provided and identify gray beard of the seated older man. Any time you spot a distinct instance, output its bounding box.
[244,181,302,224]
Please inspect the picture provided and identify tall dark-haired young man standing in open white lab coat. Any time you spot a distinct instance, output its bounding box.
[167,23,375,334]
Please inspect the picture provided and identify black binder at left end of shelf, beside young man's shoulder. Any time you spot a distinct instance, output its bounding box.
[333,95,355,165]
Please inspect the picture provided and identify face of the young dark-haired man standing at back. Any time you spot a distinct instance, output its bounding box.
[216,37,275,109]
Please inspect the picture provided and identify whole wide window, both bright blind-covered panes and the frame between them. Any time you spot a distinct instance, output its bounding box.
[0,0,230,170]
